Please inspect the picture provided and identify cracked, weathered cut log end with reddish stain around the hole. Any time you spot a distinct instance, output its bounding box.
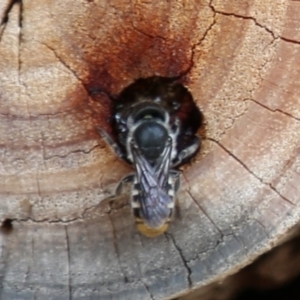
[0,0,300,300]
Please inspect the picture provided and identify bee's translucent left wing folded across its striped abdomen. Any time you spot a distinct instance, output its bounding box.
[132,145,172,228]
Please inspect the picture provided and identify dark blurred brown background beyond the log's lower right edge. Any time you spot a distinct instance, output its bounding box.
[176,225,300,300]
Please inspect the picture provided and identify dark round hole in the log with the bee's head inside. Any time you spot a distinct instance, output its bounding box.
[112,76,205,164]
